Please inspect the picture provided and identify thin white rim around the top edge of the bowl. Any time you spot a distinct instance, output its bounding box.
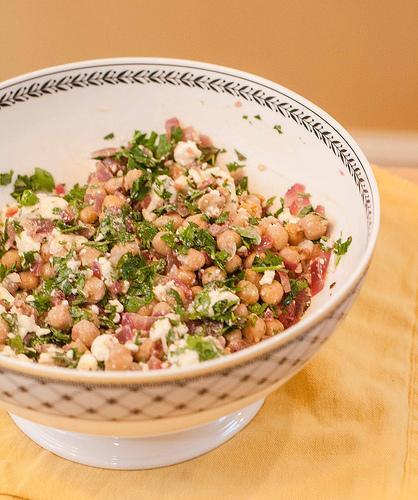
[0,57,380,385]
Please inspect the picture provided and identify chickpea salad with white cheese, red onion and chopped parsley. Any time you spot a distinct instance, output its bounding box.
[0,118,351,370]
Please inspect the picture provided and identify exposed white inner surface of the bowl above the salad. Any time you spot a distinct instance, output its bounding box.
[0,60,376,370]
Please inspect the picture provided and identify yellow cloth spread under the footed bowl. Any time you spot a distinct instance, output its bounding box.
[0,168,418,500]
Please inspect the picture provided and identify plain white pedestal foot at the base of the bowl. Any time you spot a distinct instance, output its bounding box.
[10,400,264,470]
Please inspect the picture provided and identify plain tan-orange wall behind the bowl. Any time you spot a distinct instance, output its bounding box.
[0,0,418,131]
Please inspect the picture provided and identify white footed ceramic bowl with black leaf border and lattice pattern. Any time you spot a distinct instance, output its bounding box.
[0,58,379,468]
